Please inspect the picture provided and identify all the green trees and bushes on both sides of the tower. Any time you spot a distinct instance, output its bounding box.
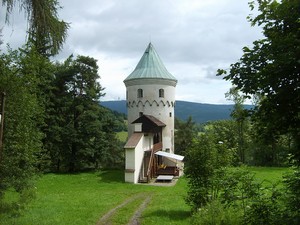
[0,0,300,224]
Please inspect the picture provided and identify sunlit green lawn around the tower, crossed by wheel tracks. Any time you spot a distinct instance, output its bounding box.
[0,167,287,225]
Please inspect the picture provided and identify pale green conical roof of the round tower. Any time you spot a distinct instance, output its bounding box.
[124,43,177,82]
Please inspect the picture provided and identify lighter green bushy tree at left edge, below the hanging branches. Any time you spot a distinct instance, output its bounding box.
[0,47,44,209]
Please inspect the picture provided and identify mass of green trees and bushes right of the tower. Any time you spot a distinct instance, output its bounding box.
[177,0,300,224]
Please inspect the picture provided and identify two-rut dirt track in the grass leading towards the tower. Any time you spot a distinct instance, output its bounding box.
[97,193,152,225]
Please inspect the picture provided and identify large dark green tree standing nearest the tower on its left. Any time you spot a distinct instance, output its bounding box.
[46,56,103,172]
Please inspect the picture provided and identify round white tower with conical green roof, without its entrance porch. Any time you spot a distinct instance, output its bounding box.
[124,43,177,153]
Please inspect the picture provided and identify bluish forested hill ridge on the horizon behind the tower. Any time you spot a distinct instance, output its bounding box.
[101,100,251,123]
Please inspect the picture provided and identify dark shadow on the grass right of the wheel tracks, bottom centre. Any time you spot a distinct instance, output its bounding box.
[143,209,191,222]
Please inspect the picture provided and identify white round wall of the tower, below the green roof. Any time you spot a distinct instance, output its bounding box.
[127,79,175,153]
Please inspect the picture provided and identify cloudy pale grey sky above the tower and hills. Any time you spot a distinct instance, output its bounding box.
[0,0,262,104]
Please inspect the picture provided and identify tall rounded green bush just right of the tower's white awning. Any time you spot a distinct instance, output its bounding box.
[184,135,236,211]
